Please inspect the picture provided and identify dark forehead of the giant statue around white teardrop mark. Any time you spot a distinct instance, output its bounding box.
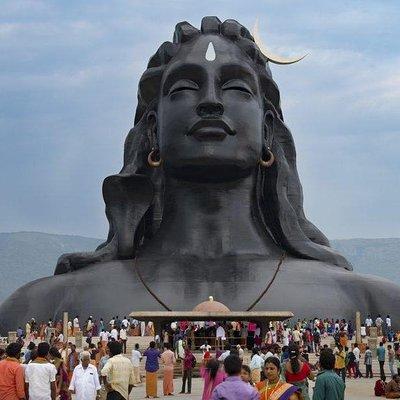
[164,35,254,76]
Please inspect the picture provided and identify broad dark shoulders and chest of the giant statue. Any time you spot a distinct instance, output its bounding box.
[0,257,400,335]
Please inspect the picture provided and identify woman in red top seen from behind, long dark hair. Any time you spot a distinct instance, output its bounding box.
[284,344,315,400]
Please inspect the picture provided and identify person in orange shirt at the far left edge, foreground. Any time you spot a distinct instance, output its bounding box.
[0,343,25,400]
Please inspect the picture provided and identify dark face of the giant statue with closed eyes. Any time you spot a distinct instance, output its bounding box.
[157,35,264,180]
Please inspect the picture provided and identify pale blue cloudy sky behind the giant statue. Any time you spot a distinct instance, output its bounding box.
[0,0,400,238]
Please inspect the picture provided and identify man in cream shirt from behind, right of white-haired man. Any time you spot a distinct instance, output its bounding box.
[101,341,134,400]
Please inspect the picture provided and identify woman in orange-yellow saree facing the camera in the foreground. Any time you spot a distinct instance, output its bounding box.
[256,357,304,400]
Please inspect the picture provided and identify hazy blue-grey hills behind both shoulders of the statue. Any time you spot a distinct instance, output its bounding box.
[0,232,400,302]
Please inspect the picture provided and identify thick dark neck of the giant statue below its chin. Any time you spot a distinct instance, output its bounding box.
[142,172,280,258]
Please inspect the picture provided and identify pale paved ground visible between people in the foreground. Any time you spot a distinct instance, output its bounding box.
[129,378,377,400]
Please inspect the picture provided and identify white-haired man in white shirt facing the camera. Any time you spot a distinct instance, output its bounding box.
[69,351,101,400]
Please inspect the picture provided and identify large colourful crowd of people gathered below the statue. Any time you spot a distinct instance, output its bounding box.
[0,316,400,400]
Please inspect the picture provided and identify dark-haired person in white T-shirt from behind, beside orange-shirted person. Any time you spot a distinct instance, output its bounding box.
[25,342,57,400]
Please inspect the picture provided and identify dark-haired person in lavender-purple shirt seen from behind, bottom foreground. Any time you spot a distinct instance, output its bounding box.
[211,354,259,400]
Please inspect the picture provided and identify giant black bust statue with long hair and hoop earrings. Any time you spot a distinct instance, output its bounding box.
[0,17,400,330]
